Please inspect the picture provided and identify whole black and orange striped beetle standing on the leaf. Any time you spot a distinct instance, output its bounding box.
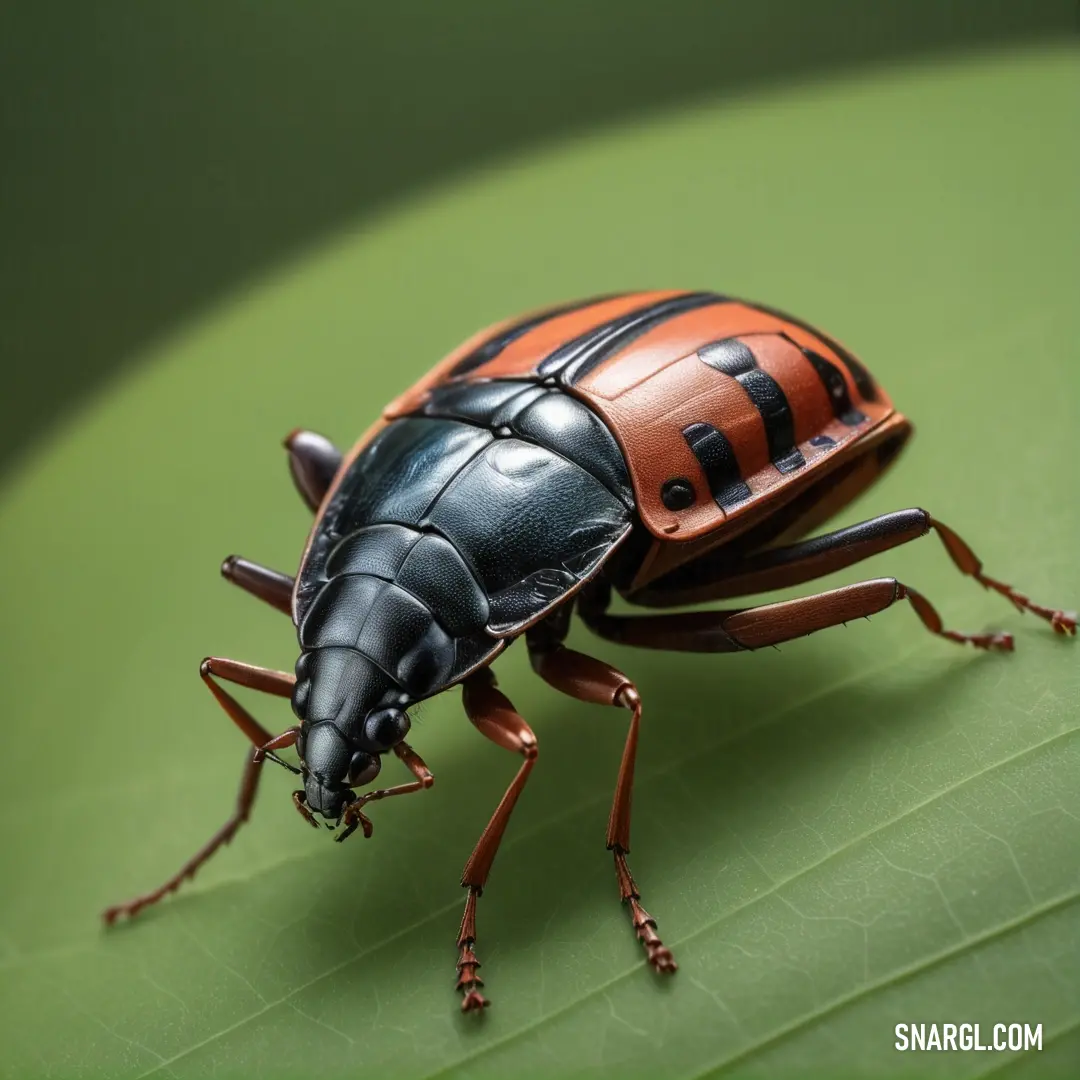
[104,291,1077,1012]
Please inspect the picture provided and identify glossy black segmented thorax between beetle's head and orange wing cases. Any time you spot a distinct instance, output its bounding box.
[296,380,634,725]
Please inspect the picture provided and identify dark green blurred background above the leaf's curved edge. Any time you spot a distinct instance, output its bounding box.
[0,0,1077,468]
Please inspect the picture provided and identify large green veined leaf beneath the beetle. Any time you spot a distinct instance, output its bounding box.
[0,49,1080,1078]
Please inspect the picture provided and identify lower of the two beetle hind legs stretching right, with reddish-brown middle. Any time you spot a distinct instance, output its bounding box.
[581,578,1013,652]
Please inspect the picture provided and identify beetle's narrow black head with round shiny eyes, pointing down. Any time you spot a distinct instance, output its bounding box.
[293,649,409,822]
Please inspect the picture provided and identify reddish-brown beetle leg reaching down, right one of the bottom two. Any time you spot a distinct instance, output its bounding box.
[527,623,678,974]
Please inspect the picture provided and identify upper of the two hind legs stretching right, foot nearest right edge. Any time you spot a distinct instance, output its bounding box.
[632,509,1077,634]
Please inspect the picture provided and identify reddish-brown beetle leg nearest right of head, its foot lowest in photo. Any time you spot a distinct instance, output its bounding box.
[457,667,538,1012]
